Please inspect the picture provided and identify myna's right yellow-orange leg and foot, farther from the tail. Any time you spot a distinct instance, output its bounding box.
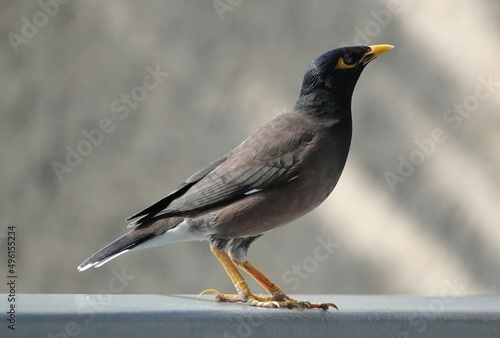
[234,260,338,310]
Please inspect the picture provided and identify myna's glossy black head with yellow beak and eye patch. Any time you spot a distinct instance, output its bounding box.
[297,45,394,112]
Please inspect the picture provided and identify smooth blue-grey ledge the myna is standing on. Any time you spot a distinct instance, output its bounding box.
[0,294,500,338]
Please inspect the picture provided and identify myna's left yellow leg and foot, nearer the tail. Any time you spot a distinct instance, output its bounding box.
[198,244,286,307]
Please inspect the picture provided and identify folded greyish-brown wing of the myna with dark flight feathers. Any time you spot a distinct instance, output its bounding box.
[128,113,314,226]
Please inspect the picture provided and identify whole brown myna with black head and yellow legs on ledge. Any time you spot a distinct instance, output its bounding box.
[78,44,394,310]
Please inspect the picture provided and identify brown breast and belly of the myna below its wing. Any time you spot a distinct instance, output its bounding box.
[210,120,350,238]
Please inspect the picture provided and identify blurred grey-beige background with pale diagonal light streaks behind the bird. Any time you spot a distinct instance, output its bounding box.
[0,0,500,296]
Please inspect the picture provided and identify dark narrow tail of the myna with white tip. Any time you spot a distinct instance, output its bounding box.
[77,218,182,271]
